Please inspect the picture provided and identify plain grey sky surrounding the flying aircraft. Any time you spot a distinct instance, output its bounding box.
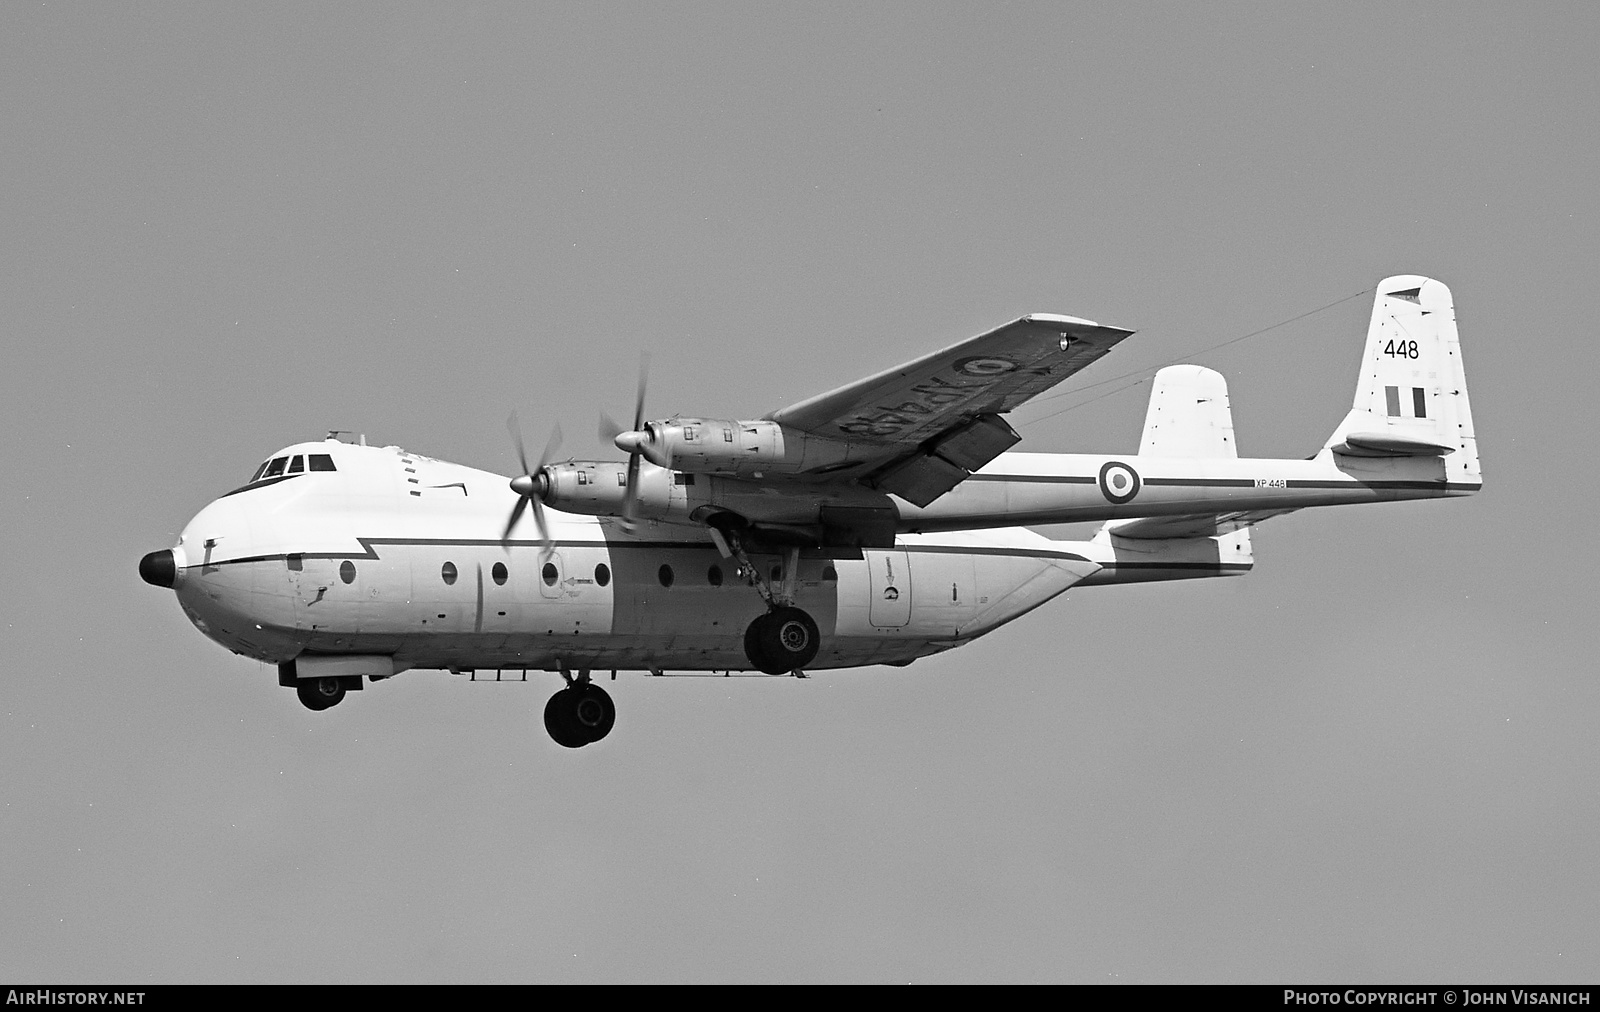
[0,3,1600,982]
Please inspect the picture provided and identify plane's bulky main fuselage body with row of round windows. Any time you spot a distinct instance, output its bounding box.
[174,442,1101,671]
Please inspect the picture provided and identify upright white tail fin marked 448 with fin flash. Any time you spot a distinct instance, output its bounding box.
[1326,274,1482,482]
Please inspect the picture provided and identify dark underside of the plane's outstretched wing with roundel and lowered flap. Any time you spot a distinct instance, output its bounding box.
[766,314,1133,506]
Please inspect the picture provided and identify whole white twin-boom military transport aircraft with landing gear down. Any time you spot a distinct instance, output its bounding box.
[139,275,1482,748]
